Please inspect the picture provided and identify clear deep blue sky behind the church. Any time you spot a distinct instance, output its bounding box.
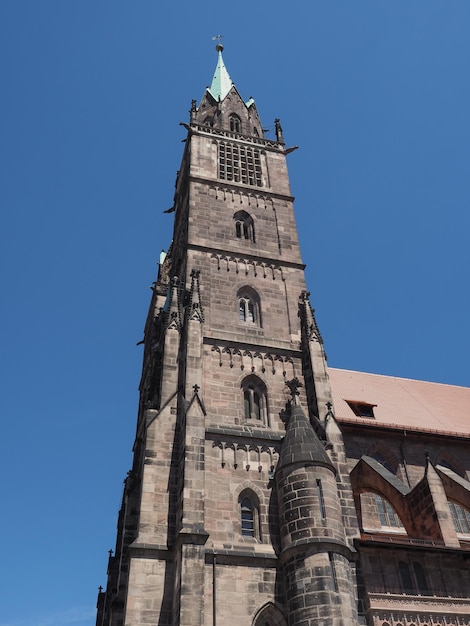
[0,0,470,626]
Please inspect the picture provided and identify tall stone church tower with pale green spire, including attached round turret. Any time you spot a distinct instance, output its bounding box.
[97,43,359,626]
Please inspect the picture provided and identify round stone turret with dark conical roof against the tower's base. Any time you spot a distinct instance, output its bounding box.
[275,386,357,626]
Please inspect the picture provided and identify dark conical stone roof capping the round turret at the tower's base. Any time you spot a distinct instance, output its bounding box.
[277,404,334,469]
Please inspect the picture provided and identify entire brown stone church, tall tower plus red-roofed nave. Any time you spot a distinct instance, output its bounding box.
[96,43,470,626]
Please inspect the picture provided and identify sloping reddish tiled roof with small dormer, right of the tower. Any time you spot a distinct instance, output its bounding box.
[329,368,470,436]
